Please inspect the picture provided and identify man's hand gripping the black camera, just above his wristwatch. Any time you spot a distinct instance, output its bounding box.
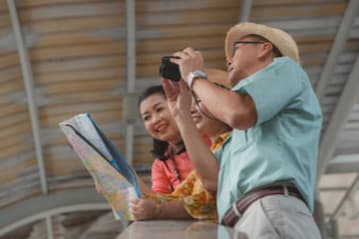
[171,47,203,82]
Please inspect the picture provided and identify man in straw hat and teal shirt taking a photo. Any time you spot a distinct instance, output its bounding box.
[166,23,322,239]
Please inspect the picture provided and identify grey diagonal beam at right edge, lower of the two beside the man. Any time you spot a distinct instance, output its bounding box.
[317,56,359,181]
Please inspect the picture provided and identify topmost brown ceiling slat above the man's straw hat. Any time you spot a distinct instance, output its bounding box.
[251,1,347,21]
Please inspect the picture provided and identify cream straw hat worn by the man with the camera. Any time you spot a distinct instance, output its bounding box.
[225,22,300,63]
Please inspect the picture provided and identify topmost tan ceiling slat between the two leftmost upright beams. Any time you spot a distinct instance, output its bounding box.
[18,1,126,22]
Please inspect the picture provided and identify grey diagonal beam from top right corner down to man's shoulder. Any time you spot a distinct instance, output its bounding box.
[315,0,359,100]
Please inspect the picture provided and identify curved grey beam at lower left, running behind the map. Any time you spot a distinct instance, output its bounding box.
[0,187,110,236]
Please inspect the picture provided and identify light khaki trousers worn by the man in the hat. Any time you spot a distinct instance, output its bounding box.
[234,195,321,239]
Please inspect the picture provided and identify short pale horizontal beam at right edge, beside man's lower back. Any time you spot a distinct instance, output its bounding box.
[325,154,359,174]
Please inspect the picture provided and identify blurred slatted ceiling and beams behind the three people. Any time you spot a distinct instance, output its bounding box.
[0,0,359,239]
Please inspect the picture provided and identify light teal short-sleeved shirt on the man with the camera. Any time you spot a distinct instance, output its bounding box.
[215,57,322,219]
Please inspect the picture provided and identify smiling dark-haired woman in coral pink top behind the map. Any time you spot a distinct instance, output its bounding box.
[138,85,204,194]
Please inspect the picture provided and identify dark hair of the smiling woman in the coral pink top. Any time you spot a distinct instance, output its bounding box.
[137,85,169,161]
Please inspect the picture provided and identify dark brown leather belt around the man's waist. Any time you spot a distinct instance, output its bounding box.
[221,185,304,227]
